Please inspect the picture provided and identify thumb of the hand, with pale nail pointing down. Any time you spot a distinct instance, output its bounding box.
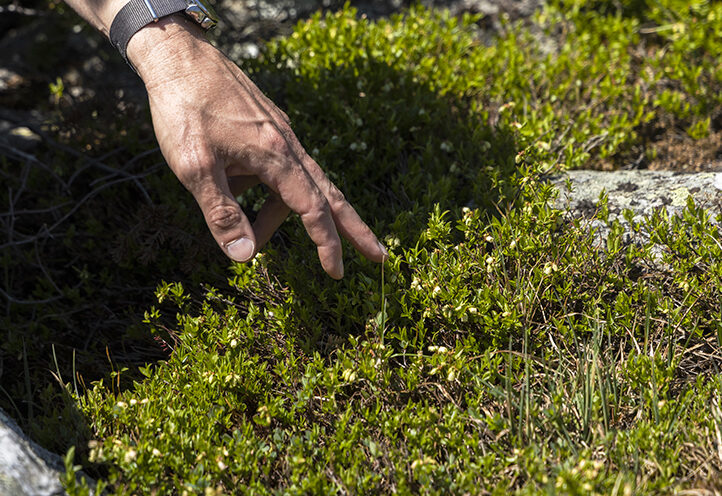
[195,178,256,262]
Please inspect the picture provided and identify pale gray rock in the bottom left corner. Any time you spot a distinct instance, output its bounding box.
[0,410,65,496]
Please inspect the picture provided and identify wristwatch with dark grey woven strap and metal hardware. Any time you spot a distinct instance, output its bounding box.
[110,0,218,67]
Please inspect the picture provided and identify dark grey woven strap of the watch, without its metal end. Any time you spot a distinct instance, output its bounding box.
[110,0,188,67]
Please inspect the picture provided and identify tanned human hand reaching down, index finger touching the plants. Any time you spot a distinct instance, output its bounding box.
[128,16,388,279]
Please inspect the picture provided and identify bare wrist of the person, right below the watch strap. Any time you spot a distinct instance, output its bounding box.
[127,13,211,85]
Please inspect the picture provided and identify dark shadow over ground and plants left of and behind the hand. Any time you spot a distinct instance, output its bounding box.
[0,0,516,476]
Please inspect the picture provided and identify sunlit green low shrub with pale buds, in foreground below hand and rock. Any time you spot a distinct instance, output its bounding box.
[79,181,722,494]
